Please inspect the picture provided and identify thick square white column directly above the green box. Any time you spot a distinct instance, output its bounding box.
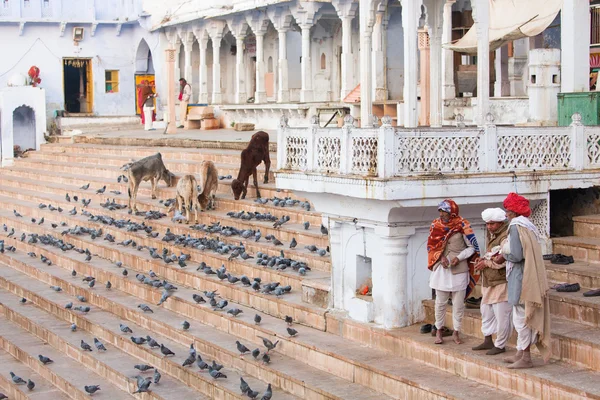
[560,0,591,92]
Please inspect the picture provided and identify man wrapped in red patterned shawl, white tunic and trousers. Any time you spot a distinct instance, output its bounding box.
[427,199,479,344]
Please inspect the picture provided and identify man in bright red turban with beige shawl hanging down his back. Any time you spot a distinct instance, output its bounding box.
[495,193,551,369]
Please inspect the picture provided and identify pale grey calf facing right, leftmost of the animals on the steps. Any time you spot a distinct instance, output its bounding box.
[127,153,175,212]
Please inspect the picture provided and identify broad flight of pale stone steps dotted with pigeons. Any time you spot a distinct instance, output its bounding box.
[0,138,600,399]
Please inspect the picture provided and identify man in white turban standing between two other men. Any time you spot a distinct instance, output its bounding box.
[473,208,512,355]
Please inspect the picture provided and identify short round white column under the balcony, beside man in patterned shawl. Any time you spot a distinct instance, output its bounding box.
[372,227,414,329]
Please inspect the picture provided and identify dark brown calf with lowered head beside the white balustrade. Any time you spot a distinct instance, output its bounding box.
[231,131,271,200]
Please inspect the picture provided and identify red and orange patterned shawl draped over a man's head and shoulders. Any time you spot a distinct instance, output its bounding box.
[427,199,479,296]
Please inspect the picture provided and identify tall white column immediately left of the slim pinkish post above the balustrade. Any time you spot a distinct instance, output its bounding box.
[402,0,421,128]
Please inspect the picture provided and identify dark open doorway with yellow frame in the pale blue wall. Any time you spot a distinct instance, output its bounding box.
[63,58,94,114]
